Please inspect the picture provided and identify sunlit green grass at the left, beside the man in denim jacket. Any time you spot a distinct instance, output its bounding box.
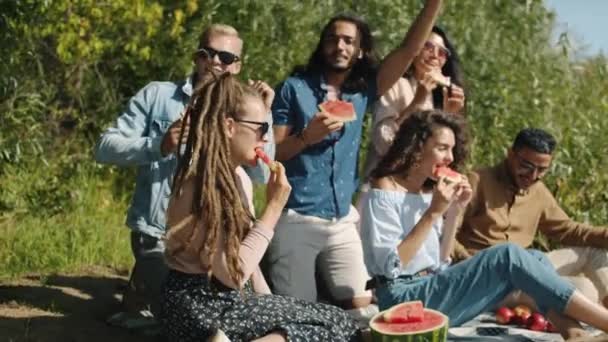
[0,167,132,278]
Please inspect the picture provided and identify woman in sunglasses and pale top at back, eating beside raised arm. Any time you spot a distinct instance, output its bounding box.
[365,26,465,178]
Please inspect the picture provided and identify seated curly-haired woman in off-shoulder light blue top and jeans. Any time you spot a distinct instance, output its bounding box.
[361,110,608,337]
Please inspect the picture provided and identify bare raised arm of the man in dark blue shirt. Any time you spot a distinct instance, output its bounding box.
[377,0,442,96]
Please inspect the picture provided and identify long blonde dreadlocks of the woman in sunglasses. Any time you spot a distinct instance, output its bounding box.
[172,72,259,284]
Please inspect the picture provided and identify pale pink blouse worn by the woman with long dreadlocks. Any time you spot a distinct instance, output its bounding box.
[165,167,274,294]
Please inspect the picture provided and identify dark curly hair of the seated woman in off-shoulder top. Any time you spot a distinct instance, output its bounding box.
[371,109,469,187]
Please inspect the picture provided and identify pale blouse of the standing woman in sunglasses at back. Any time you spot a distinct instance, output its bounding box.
[364,77,433,179]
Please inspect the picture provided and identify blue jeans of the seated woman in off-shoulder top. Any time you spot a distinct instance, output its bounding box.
[376,243,574,326]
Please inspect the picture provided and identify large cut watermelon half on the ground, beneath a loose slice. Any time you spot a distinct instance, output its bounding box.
[369,309,449,342]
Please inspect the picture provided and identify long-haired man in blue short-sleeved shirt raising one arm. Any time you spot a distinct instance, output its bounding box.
[268,0,442,317]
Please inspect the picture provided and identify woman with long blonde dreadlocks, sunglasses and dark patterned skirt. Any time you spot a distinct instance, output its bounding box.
[162,74,359,341]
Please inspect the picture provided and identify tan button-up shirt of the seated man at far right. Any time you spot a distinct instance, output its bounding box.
[454,162,608,260]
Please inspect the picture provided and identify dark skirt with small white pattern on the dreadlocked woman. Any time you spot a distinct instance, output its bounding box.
[161,270,359,342]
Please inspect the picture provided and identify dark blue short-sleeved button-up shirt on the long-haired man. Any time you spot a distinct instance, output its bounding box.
[272,75,377,219]
